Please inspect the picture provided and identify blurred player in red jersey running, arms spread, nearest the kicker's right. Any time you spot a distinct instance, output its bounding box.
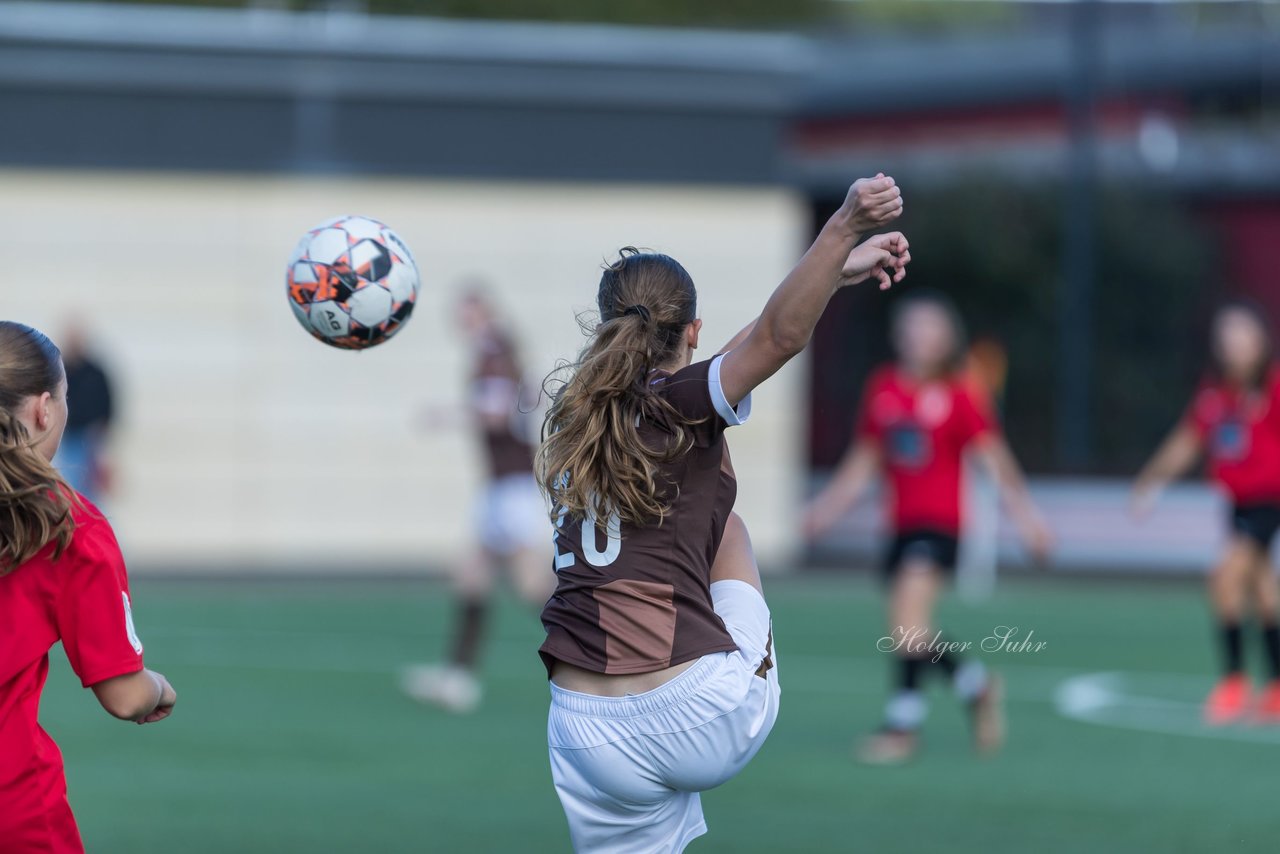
[804,291,1051,763]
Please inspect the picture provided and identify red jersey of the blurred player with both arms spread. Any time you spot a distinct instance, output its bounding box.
[856,367,996,535]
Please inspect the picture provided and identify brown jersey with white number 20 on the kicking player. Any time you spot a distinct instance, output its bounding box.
[539,356,750,673]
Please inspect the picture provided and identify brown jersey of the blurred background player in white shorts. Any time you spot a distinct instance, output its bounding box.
[471,333,534,479]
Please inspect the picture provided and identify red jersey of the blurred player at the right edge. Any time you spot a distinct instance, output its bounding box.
[1185,369,1280,504]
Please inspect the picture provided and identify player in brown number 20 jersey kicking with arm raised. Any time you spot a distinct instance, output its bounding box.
[538,175,909,853]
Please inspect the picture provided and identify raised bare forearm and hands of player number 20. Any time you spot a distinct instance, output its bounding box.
[721,175,910,405]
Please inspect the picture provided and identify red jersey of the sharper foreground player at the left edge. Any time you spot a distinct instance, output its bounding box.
[0,499,142,854]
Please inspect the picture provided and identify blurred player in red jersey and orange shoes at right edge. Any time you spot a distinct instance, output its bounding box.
[1133,302,1280,725]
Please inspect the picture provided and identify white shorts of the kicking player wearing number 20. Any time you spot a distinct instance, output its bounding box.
[547,581,780,854]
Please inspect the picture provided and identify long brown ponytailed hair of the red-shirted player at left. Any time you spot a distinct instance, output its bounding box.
[0,320,76,575]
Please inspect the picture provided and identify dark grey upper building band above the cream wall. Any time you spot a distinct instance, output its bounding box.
[0,4,804,184]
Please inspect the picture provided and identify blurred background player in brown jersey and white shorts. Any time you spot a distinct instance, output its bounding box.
[403,286,556,713]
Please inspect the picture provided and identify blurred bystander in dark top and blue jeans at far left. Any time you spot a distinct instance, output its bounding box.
[54,320,115,503]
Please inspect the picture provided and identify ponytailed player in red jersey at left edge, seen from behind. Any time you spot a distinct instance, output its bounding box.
[0,321,178,854]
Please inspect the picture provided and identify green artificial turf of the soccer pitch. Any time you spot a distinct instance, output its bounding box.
[44,576,1280,854]
